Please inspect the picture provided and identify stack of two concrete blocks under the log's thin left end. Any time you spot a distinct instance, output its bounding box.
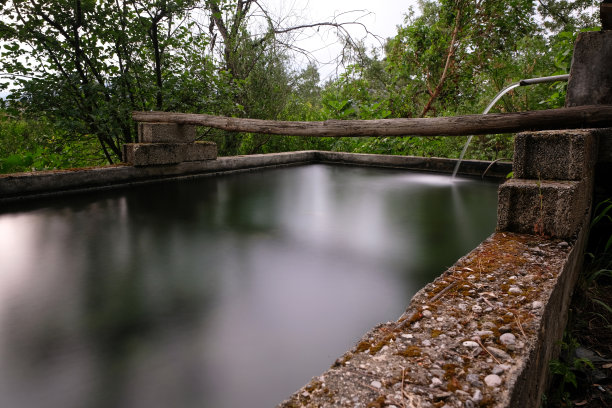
[123,123,217,166]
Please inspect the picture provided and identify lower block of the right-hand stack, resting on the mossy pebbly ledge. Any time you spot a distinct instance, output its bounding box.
[497,179,591,239]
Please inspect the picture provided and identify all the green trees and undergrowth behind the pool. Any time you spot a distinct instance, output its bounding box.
[0,0,597,172]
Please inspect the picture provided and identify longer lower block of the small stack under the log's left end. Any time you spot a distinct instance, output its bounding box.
[124,142,217,166]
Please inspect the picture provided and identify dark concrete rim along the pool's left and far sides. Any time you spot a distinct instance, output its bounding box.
[0,150,510,203]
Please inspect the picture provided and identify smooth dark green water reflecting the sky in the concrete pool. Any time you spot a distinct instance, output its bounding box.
[0,165,496,408]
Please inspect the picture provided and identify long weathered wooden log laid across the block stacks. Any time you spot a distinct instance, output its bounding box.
[132,105,612,137]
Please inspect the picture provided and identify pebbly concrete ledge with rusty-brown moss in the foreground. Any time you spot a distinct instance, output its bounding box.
[280,228,586,408]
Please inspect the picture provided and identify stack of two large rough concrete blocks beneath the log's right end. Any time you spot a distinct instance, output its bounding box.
[497,129,598,239]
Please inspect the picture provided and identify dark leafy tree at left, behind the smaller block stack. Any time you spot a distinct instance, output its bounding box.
[0,0,216,163]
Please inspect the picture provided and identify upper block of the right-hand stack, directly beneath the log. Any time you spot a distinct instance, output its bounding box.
[513,130,597,180]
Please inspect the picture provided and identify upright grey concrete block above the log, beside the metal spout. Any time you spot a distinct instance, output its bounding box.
[565,30,612,107]
